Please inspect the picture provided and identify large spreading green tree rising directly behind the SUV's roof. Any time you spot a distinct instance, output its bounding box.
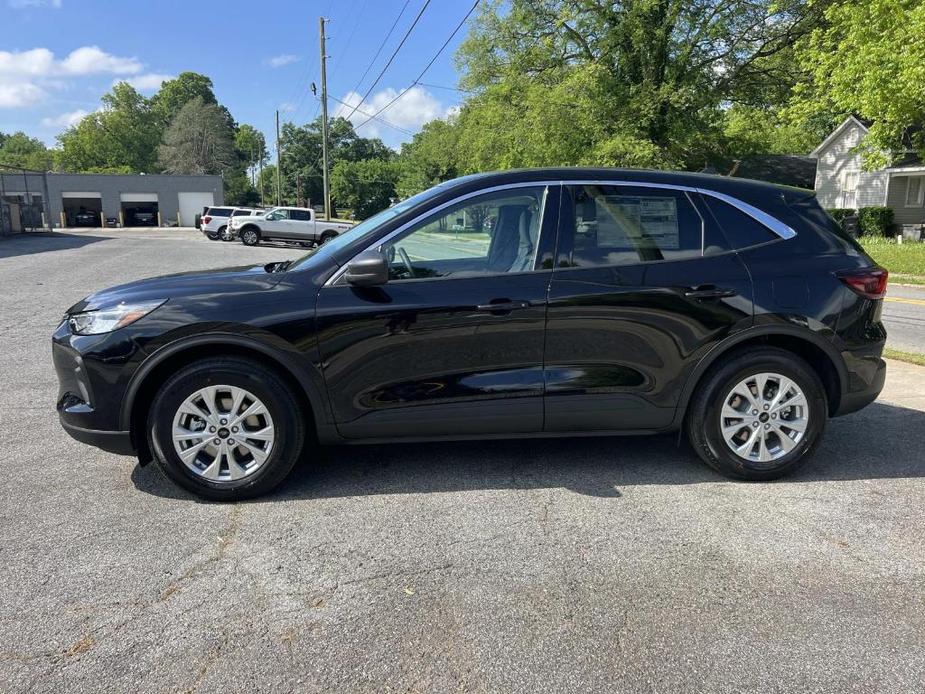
[457,0,830,173]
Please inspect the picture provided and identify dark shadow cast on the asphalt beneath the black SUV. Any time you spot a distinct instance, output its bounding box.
[132,403,925,501]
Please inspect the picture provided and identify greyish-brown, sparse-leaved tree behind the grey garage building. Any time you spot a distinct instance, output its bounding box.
[158,97,239,174]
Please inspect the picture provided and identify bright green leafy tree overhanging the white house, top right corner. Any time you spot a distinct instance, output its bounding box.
[792,0,925,168]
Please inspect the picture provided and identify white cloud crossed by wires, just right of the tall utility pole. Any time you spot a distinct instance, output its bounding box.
[333,86,455,139]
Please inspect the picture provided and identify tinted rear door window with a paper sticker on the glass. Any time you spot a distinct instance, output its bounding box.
[557,185,704,267]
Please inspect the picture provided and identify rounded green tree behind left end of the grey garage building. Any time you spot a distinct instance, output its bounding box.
[56,82,161,173]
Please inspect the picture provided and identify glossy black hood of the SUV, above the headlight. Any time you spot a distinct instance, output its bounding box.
[68,263,285,313]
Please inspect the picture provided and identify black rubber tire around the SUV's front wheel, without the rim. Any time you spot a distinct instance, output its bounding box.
[147,357,306,501]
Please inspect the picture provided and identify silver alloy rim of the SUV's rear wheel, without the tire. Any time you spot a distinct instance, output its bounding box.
[720,373,809,465]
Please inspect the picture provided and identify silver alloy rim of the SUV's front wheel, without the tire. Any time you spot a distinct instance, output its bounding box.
[173,385,276,483]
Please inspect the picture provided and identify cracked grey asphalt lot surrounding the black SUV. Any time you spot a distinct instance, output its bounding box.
[0,230,925,693]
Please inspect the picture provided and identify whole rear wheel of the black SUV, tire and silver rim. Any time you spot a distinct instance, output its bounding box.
[687,347,828,480]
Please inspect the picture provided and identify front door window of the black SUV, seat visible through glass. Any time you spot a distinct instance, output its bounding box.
[382,186,545,280]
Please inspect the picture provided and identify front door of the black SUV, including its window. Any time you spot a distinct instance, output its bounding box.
[317,186,559,438]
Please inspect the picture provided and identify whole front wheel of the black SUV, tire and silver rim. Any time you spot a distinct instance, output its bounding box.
[148,357,305,501]
